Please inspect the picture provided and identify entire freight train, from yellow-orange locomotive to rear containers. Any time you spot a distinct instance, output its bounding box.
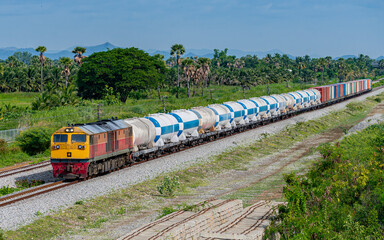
[50,79,372,179]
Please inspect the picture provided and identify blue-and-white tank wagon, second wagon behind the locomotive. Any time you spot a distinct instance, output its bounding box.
[146,113,179,147]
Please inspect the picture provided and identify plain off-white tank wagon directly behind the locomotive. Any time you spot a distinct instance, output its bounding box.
[123,118,156,151]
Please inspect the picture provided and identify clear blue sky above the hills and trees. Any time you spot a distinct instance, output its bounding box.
[0,0,384,58]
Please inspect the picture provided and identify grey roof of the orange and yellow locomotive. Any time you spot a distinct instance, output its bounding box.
[77,120,130,134]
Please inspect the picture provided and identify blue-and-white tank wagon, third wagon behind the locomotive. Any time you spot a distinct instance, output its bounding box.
[169,109,200,140]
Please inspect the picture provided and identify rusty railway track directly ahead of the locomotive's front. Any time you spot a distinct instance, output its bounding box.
[0,181,79,207]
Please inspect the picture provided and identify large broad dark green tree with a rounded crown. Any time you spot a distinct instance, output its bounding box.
[77,47,166,102]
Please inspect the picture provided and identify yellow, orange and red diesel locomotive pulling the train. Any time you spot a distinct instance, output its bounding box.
[51,120,133,179]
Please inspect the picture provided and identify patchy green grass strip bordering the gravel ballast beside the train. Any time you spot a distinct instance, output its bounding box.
[5,94,384,239]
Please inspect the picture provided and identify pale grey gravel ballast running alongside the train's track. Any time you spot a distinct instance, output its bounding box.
[0,89,384,229]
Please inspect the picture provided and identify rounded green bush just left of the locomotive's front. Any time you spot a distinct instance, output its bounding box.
[16,127,51,155]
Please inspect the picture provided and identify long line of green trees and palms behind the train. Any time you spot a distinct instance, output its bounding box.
[0,44,384,106]
